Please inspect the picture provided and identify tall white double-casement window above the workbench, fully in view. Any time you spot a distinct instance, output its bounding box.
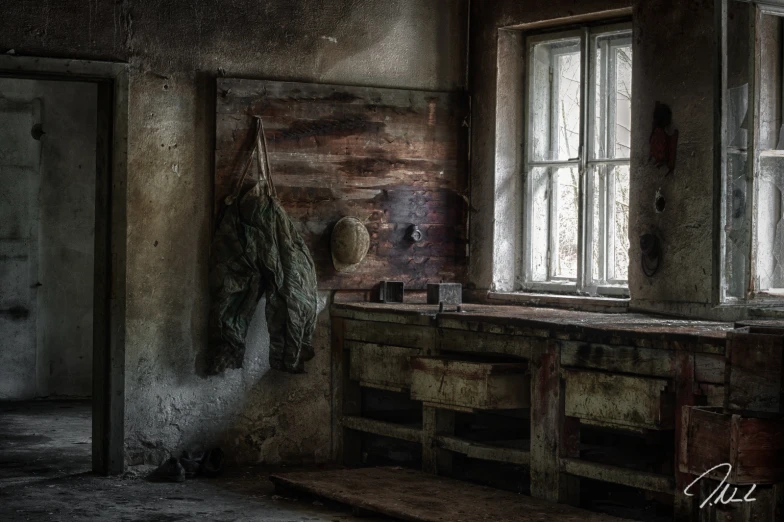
[523,24,632,295]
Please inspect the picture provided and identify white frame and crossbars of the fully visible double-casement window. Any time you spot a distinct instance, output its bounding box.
[522,21,633,297]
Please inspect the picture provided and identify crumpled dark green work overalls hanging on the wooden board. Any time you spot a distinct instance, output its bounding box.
[208,117,318,374]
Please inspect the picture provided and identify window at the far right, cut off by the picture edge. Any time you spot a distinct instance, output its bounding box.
[720,0,784,303]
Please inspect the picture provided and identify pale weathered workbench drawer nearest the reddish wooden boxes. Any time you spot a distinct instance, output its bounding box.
[561,370,675,430]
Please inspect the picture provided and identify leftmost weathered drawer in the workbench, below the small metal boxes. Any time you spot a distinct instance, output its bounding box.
[345,341,421,391]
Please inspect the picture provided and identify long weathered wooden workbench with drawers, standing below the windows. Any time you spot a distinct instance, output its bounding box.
[332,303,784,521]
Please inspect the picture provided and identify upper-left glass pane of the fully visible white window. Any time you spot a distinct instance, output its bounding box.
[528,38,582,161]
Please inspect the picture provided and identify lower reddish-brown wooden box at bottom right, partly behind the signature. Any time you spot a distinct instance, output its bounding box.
[678,406,784,485]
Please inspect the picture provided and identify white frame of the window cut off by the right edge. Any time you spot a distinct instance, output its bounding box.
[718,0,784,306]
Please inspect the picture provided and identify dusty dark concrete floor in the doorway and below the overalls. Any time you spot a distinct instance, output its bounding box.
[0,401,388,522]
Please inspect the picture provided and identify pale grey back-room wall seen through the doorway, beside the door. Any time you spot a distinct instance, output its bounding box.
[0,79,97,398]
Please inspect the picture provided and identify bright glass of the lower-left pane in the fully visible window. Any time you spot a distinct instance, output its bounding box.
[551,168,580,279]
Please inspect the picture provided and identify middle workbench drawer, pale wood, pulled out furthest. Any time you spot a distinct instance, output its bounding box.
[411,357,531,411]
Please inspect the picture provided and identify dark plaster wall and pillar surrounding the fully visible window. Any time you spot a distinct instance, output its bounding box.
[469,0,720,317]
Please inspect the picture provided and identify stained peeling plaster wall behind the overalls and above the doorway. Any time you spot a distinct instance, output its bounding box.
[0,0,468,463]
